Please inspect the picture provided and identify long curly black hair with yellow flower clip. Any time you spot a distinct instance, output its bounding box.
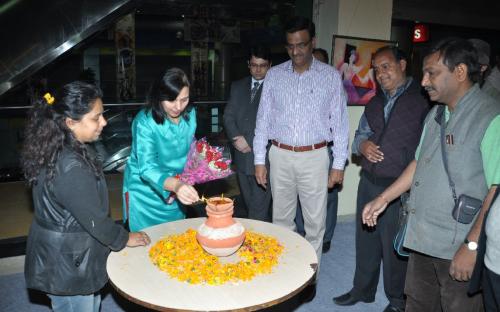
[21,81,102,186]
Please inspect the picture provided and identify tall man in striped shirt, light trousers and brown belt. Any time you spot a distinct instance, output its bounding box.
[254,17,349,301]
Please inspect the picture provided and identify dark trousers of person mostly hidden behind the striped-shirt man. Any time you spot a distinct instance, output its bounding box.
[295,185,339,243]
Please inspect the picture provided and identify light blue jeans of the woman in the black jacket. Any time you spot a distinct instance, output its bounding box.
[47,293,101,312]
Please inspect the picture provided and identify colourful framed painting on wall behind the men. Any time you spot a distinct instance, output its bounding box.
[331,35,397,105]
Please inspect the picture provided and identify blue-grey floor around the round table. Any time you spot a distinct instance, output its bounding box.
[0,216,388,312]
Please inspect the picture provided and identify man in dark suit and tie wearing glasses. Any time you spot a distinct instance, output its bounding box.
[224,46,271,222]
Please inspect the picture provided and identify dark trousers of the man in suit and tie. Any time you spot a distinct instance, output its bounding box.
[237,172,272,222]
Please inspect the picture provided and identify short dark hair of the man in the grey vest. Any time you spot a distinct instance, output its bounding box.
[425,37,481,83]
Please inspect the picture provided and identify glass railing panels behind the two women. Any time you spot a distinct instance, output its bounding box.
[0,101,231,182]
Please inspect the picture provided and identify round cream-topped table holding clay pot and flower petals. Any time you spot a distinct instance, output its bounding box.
[107,218,318,311]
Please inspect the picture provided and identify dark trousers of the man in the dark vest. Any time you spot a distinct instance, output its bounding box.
[351,173,407,308]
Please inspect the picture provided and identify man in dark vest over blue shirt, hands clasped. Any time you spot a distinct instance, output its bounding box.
[333,46,429,312]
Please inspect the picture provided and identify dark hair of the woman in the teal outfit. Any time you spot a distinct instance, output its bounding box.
[146,67,192,125]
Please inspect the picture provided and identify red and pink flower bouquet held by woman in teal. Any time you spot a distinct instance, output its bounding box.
[167,138,233,204]
